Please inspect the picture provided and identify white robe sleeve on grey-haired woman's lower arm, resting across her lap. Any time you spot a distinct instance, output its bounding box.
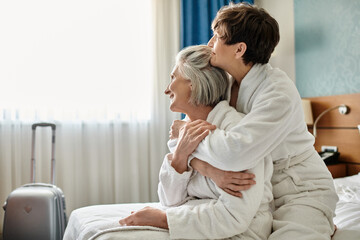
[166,158,272,239]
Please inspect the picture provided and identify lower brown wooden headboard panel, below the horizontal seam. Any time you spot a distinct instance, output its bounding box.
[314,129,360,163]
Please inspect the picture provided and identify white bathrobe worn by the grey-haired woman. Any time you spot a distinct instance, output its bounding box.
[158,101,273,239]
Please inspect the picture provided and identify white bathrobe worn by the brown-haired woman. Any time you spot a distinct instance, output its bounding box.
[187,64,338,240]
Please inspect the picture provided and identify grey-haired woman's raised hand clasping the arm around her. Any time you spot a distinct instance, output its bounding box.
[171,120,216,173]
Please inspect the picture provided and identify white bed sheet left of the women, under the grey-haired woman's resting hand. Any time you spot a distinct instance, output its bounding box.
[63,203,170,240]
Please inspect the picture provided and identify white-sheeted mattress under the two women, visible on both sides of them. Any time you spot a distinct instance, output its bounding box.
[64,173,360,240]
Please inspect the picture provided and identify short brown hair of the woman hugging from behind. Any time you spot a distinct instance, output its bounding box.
[211,3,280,64]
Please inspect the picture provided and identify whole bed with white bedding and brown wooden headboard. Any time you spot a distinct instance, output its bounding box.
[64,94,360,240]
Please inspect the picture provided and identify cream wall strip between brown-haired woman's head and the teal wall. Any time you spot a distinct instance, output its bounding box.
[255,0,296,82]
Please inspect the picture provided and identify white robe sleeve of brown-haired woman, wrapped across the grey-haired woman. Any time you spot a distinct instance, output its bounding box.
[192,79,303,171]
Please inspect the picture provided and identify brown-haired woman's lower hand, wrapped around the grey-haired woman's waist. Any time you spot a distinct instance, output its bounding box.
[191,158,256,197]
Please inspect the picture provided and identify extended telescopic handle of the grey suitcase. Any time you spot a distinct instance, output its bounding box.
[31,122,56,185]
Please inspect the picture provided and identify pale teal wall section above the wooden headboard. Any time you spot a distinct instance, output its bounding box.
[294,0,360,97]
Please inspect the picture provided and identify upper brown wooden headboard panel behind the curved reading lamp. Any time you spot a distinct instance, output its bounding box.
[307,93,360,128]
